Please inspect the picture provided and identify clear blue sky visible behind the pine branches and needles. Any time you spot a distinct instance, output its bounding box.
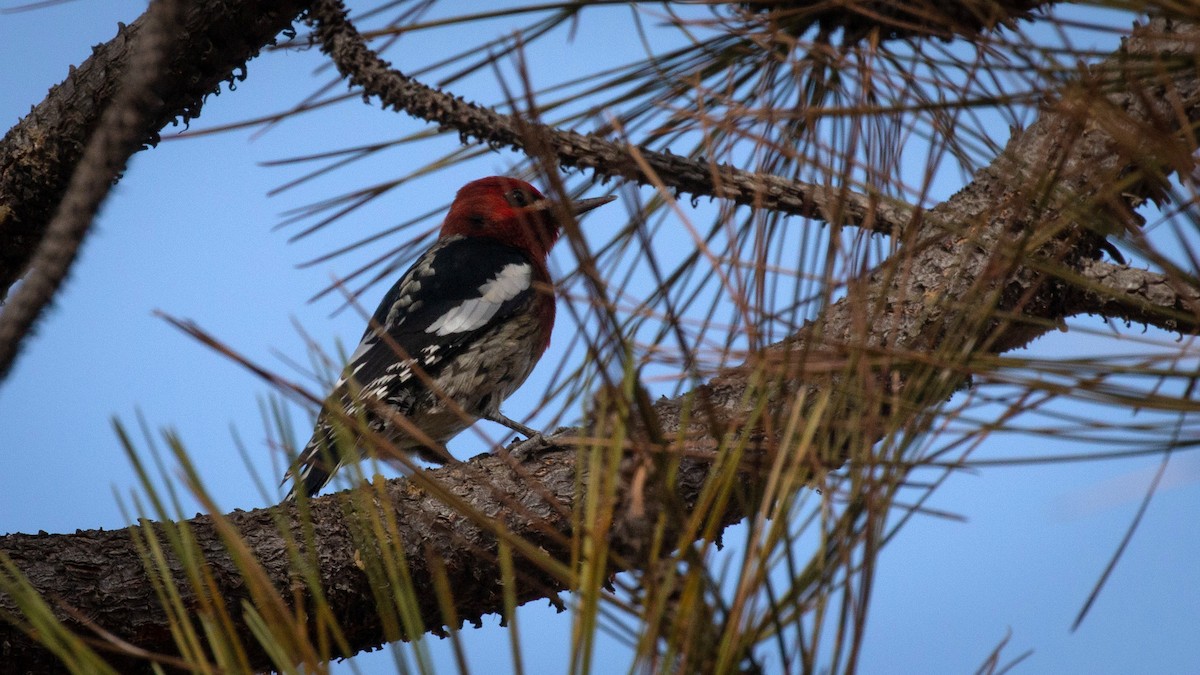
[0,0,1200,674]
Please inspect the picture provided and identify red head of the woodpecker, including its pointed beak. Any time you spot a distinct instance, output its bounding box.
[440,175,613,261]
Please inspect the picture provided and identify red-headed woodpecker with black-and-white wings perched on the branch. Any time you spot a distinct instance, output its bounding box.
[283,175,616,501]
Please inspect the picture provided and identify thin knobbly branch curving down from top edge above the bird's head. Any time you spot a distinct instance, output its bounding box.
[310,0,916,233]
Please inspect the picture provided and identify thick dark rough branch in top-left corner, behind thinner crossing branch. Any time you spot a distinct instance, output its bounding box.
[0,0,308,295]
